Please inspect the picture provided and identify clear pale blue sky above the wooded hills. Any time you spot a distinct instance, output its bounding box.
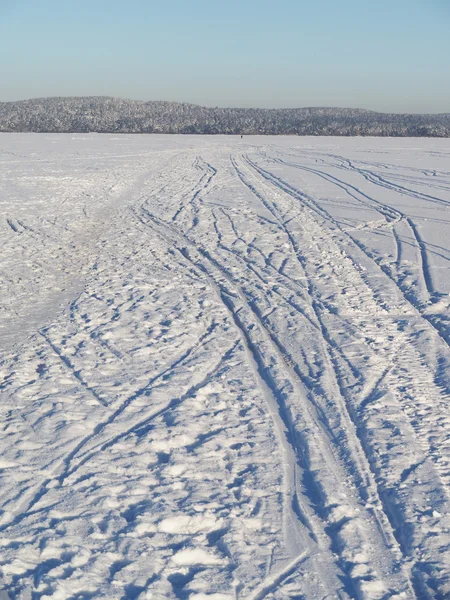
[0,0,450,112]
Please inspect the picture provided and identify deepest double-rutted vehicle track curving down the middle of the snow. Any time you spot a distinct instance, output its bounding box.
[135,198,414,598]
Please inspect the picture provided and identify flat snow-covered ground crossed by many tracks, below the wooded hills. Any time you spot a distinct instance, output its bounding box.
[0,134,450,600]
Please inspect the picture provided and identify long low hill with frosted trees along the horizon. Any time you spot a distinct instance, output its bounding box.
[0,96,450,137]
